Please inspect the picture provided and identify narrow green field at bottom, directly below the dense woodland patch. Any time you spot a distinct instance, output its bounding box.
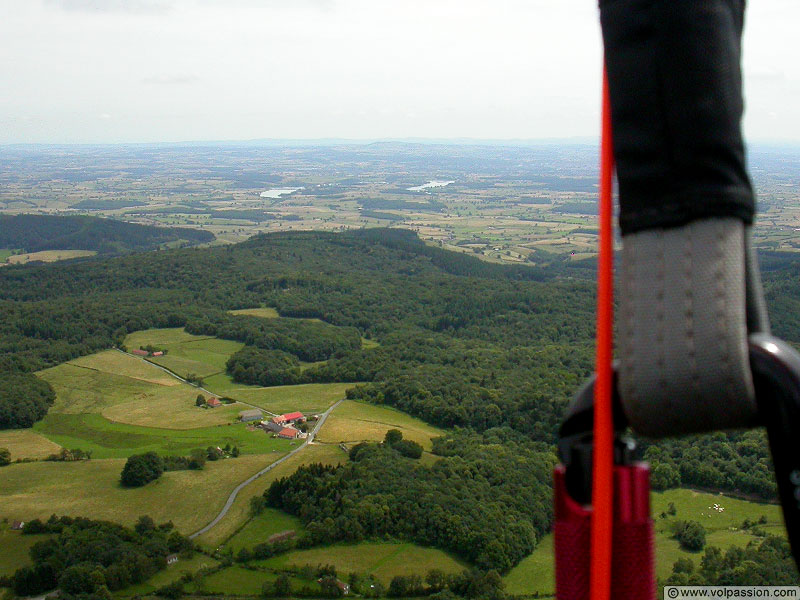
[257,542,468,584]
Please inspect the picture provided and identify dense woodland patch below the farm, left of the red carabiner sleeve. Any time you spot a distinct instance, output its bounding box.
[264,429,555,572]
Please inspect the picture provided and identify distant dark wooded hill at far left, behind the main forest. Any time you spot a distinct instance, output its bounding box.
[0,215,214,254]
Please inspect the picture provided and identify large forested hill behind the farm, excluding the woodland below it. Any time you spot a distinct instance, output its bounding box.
[0,229,800,497]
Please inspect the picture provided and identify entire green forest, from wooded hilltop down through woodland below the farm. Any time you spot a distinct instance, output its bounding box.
[0,229,800,570]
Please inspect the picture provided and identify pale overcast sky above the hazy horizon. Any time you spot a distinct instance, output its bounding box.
[0,0,800,143]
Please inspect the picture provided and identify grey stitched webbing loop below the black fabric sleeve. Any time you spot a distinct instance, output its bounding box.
[619,218,756,437]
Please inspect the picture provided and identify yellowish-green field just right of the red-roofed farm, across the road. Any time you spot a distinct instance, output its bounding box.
[317,400,444,450]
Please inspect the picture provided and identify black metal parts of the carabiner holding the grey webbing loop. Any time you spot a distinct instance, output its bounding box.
[558,333,800,566]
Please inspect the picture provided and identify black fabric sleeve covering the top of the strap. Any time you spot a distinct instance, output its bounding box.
[600,0,754,235]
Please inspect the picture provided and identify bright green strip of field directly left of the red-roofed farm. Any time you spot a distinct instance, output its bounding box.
[33,409,291,458]
